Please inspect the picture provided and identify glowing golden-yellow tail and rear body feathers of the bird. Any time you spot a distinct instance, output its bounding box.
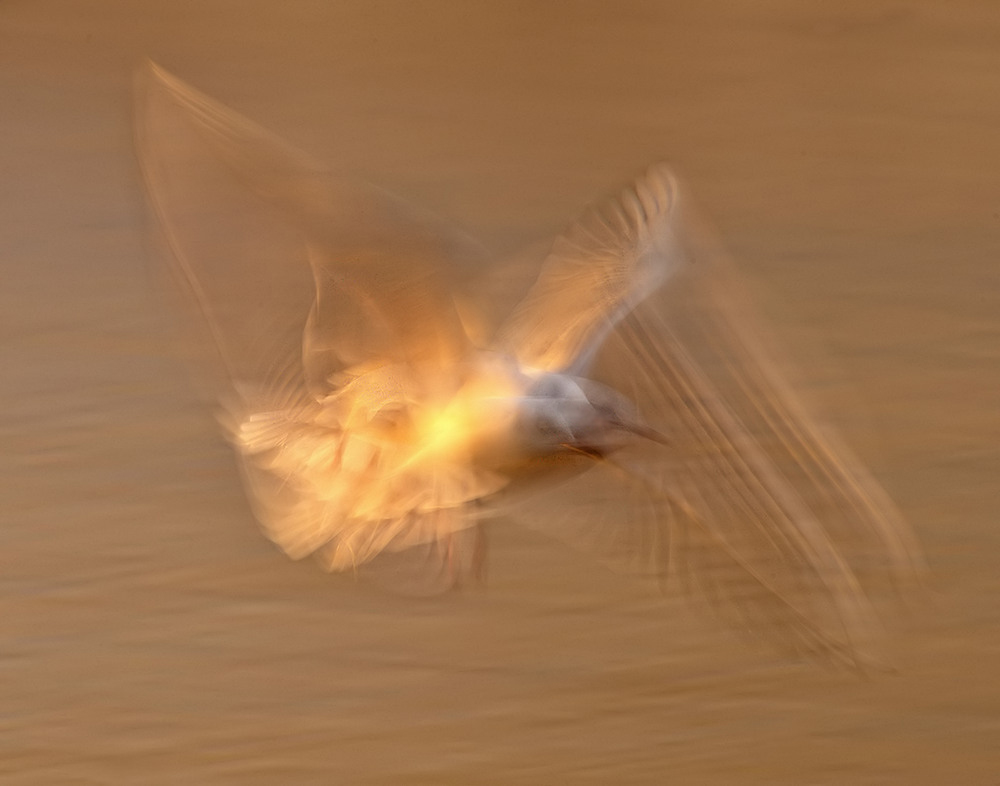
[233,364,512,570]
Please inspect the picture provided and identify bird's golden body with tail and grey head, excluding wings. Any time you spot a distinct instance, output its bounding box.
[231,336,643,569]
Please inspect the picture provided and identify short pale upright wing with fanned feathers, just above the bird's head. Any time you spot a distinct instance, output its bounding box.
[497,164,678,375]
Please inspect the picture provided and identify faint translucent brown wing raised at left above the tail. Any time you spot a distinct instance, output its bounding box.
[136,63,482,402]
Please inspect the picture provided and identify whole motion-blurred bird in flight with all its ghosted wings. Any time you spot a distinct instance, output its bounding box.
[134,62,921,668]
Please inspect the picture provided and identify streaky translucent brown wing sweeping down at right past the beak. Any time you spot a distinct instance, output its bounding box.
[498,168,920,665]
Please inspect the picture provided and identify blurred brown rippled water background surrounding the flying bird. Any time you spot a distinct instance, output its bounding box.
[0,0,1000,784]
